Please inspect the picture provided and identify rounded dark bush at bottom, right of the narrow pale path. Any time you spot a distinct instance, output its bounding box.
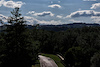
[65,47,89,67]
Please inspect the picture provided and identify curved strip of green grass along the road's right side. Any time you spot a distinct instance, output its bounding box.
[41,53,65,67]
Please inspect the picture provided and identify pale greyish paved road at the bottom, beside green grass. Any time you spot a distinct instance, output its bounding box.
[39,55,58,67]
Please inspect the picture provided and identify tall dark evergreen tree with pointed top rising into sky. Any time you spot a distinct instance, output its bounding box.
[2,7,37,67]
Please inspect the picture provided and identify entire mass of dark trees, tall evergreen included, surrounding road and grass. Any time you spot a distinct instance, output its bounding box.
[0,8,100,67]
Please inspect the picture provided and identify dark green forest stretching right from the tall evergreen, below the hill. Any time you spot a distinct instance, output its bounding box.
[28,27,100,67]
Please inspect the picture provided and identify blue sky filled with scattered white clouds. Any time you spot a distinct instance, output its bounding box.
[0,0,100,25]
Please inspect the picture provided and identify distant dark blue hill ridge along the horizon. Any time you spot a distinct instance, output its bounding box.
[0,23,100,31]
